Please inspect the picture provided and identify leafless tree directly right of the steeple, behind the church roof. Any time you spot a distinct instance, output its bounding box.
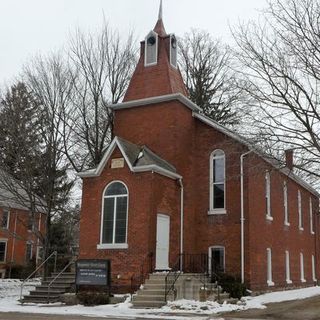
[179,30,241,125]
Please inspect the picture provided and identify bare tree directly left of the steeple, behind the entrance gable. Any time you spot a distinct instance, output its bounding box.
[64,23,136,171]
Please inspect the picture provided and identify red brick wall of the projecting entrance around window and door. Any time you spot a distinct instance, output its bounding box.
[80,150,179,285]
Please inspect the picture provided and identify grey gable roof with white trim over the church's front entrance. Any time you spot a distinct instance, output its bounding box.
[78,137,182,179]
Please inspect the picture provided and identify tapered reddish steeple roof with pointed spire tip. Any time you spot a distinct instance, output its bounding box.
[123,0,188,102]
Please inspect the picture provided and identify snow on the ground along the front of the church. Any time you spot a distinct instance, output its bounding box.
[0,279,320,320]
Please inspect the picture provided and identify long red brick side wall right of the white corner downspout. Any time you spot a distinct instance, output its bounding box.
[246,156,318,289]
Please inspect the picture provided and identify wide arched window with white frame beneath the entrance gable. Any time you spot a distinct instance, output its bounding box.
[101,181,128,245]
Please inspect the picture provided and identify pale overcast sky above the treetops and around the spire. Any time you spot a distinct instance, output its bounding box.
[0,0,266,84]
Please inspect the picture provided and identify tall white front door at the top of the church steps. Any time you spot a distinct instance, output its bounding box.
[156,214,170,270]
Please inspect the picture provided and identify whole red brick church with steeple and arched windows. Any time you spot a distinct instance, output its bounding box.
[79,2,319,290]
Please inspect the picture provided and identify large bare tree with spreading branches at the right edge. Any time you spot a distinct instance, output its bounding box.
[234,0,320,184]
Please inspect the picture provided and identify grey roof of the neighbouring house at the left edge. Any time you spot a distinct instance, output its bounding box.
[0,169,45,213]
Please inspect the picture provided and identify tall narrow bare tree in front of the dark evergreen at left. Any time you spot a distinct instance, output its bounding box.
[24,54,73,262]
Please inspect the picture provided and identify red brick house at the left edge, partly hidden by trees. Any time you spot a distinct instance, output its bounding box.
[0,170,45,278]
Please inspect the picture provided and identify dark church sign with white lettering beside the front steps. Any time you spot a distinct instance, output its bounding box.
[76,259,110,286]
